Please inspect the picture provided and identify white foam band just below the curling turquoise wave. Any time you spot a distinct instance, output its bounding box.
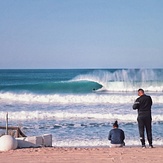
[0,93,163,104]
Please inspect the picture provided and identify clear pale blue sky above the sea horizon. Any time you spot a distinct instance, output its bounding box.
[0,0,163,68]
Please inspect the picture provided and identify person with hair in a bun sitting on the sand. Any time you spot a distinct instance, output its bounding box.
[108,121,125,148]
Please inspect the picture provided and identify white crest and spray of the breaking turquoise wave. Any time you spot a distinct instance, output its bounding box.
[73,69,163,92]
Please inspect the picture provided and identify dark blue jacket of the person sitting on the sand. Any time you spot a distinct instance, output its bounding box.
[108,128,125,144]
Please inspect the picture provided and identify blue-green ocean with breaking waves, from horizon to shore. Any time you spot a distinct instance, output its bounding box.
[0,69,163,147]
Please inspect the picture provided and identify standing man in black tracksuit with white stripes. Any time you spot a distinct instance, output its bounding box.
[133,89,153,148]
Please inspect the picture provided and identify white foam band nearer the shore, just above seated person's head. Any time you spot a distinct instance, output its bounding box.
[0,111,163,122]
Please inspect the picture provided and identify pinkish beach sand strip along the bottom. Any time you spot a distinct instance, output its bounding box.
[0,147,163,163]
